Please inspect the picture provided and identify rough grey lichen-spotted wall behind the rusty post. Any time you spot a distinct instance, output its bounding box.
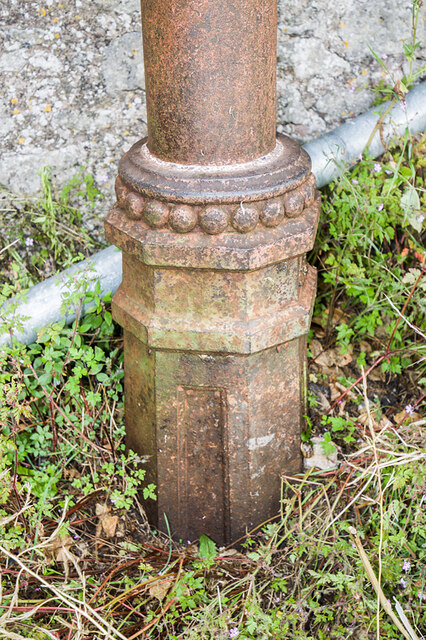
[0,0,425,200]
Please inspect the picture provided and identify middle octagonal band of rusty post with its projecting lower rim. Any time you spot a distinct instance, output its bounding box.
[113,256,315,354]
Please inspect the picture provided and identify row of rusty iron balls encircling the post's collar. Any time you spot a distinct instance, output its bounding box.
[115,173,316,235]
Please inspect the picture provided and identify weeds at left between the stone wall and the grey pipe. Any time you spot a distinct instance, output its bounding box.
[0,167,102,296]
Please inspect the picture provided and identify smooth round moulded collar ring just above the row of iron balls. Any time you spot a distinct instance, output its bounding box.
[117,134,315,206]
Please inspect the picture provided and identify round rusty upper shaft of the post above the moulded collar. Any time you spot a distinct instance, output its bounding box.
[141,0,277,165]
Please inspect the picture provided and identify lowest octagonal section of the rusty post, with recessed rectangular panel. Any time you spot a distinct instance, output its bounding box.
[125,331,306,544]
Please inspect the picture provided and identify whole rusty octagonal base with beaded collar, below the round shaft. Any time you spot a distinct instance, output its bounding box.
[105,137,320,545]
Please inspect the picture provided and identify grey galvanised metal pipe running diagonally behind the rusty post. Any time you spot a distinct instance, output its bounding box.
[0,81,426,346]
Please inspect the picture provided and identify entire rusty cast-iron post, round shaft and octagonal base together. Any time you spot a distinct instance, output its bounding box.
[105,0,320,544]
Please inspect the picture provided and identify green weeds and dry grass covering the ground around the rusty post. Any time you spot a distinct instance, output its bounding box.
[0,130,426,640]
